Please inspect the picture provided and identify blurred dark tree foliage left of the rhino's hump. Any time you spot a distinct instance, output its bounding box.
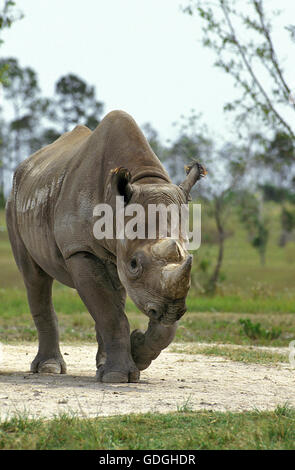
[0,62,103,182]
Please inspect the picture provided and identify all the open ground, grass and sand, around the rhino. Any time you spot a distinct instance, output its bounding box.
[0,206,295,449]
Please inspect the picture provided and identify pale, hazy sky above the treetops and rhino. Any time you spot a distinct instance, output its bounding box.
[1,0,295,140]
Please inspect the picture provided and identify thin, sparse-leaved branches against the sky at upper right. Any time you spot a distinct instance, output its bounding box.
[184,0,295,140]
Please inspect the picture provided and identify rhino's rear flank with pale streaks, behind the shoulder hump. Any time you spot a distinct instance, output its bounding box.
[8,126,91,280]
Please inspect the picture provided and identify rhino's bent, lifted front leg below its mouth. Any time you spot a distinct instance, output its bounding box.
[130,320,177,370]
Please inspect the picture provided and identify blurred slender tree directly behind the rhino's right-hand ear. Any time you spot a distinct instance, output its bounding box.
[167,112,249,293]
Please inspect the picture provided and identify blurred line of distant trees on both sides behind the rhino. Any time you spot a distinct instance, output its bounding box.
[0,58,295,290]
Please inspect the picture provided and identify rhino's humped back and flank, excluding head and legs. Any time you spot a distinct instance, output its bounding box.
[11,111,170,279]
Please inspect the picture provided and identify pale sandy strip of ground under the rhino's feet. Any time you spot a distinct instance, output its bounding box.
[0,344,295,419]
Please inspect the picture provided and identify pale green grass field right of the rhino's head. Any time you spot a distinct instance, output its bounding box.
[194,203,295,292]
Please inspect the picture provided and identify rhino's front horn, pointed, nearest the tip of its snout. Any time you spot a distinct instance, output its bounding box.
[162,255,193,299]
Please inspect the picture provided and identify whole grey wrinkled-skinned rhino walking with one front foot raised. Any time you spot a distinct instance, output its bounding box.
[6,111,206,382]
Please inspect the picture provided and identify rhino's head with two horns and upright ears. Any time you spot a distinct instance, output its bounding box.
[106,162,205,326]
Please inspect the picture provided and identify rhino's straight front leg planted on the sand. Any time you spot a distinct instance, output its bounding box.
[67,252,139,383]
